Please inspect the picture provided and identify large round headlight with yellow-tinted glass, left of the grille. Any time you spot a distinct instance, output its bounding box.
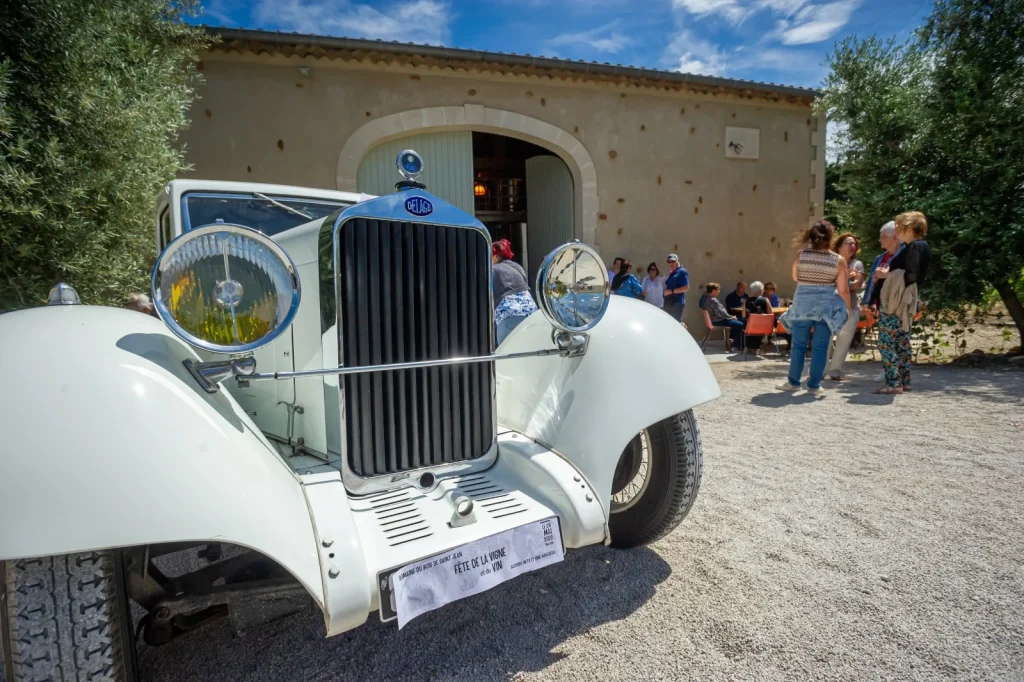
[153,223,300,353]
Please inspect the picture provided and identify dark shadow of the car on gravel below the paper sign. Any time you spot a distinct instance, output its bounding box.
[139,547,672,682]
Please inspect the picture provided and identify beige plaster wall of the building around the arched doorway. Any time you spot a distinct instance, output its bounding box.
[183,53,824,329]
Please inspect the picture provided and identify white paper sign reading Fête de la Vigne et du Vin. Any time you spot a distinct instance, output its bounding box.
[392,517,565,630]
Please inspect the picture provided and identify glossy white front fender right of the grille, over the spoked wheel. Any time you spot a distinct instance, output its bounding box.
[495,296,721,511]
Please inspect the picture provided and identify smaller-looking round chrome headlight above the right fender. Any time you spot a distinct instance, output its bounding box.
[537,242,609,332]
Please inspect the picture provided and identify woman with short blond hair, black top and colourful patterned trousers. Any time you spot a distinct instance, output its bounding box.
[871,211,932,395]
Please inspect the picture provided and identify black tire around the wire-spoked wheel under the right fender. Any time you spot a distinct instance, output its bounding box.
[608,411,703,548]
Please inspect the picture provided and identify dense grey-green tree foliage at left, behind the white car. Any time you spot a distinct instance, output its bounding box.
[0,0,206,310]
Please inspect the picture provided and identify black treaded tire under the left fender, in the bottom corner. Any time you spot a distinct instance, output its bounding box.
[0,552,136,682]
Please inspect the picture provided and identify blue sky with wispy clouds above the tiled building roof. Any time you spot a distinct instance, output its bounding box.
[198,0,932,87]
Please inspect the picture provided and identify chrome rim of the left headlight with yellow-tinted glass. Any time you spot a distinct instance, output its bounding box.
[150,222,302,354]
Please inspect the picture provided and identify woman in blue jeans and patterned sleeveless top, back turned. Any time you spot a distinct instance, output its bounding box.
[776,220,853,395]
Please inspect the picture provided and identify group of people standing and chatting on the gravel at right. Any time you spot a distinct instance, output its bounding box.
[777,211,931,395]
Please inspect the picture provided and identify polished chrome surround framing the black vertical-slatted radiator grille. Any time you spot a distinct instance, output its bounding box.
[321,188,498,495]
